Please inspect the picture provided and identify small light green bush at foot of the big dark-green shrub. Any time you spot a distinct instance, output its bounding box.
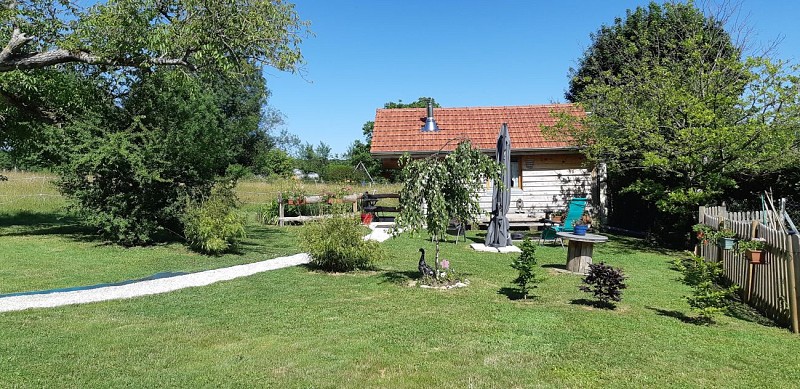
[184,184,245,254]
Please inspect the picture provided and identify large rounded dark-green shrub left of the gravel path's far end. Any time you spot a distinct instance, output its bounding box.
[59,72,246,245]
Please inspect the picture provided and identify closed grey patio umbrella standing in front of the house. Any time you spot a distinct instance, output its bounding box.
[485,123,511,247]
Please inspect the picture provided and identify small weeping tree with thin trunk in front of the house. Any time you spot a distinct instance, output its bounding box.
[396,140,501,274]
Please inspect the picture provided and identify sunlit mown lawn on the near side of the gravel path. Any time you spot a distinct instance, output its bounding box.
[0,226,800,388]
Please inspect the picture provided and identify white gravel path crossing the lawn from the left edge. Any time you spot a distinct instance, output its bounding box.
[0,254,310,312]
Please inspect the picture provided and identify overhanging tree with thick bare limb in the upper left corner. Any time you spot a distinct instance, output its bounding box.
[0,0,308,139]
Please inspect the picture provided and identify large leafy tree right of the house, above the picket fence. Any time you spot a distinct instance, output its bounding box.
[566,3,798,246]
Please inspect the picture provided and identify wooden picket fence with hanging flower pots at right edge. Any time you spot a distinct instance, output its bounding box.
[698,206,800,333]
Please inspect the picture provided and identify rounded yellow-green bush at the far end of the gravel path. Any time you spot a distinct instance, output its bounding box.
[300,216,383,271]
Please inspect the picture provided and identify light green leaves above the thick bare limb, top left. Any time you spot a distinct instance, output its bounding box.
[0,0,308,73]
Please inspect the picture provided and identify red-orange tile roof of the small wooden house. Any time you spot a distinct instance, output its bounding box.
[371,104,585,154]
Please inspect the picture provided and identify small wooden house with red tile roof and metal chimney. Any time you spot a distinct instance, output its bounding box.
[371,104,605,220]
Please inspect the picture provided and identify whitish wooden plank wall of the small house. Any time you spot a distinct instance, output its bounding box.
[480,154,593,217]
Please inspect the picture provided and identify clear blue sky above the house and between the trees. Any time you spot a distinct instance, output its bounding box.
[265,0,800,154]
